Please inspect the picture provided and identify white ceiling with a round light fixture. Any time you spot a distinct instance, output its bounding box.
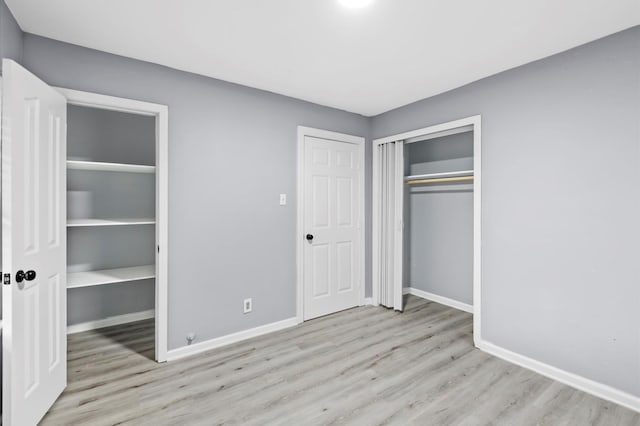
[6,0,640,116]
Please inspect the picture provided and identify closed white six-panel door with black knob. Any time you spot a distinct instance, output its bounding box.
[303,136,363,320]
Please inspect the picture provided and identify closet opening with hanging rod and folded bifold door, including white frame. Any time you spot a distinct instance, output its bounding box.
[373,116,481,345]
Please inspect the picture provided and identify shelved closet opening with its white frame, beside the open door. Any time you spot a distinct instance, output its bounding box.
[60,89,168,362]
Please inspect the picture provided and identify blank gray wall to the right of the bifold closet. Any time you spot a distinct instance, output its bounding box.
[372,27,640,396]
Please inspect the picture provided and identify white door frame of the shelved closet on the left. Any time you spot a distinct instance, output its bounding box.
[54,87,169,362]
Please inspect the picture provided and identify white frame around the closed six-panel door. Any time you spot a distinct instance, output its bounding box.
[295,126,366,324]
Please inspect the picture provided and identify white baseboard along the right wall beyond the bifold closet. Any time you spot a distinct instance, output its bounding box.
[476,340,640,412]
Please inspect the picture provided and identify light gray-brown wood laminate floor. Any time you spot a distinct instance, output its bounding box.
[42,296,640,426]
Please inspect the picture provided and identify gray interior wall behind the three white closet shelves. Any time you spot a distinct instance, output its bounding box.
[67,105,156,325]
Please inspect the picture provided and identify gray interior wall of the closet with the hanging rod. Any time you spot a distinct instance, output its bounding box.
[403,131,473,305]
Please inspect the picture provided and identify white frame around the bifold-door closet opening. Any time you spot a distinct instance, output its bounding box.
[372,115,482,346]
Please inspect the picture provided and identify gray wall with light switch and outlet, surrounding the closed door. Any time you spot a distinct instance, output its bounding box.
[23,34,371,348]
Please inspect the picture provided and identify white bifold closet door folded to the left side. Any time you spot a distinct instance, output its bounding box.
[374,141,404,311]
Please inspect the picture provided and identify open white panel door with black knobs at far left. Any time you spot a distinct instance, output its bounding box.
[2,59,67,426]
